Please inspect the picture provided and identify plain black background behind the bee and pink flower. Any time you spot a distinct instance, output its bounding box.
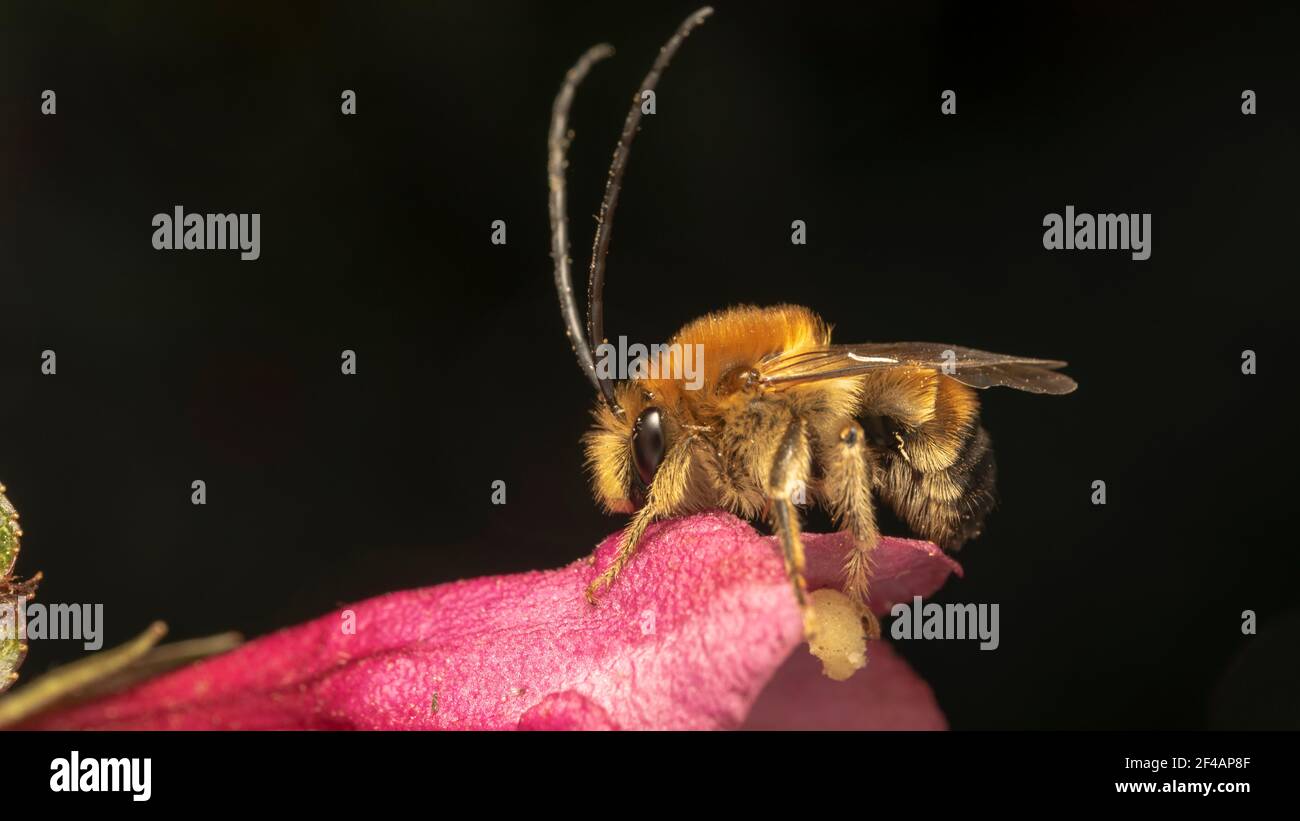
[0,3,1300,727]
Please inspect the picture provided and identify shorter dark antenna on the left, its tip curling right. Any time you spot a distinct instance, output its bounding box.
[546,43,614,397]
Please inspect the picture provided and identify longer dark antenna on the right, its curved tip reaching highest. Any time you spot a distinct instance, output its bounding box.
[587,6,714,409]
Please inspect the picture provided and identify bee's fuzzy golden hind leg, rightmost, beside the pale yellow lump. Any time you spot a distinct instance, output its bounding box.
[822,422,880,639]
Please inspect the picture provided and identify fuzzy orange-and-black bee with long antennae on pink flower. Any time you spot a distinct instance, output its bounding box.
[547,8,1076,638]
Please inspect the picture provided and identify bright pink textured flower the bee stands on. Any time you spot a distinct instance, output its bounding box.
[17,512,959,729]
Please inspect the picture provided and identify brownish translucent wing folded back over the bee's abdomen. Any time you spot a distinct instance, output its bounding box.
[759,342,1078,394]
